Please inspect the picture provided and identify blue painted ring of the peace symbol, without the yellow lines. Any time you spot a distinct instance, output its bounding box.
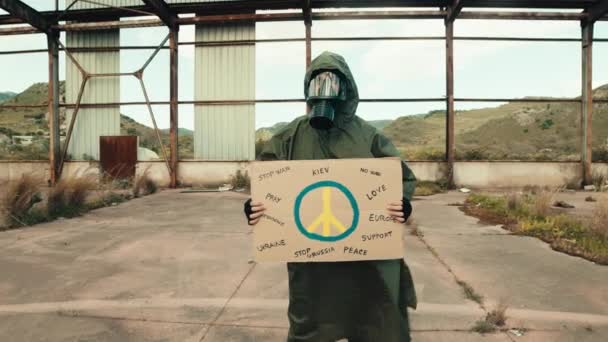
[293,181,359,242]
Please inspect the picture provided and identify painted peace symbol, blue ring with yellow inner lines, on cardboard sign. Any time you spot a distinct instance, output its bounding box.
[293,181,359,241]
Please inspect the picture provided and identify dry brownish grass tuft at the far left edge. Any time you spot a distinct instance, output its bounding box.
[2,174,44,227]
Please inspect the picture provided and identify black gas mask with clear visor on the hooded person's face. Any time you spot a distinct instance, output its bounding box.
[306,71,346,130]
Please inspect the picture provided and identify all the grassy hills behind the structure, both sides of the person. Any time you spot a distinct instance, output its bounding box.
[0,82,608,160]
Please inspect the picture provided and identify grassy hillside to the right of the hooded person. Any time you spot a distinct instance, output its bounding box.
[384,85,608,160]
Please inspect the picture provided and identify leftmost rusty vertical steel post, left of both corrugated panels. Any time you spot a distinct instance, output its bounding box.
[47,31,61,185]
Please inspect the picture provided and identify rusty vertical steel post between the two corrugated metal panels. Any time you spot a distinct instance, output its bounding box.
[169,30,179,188]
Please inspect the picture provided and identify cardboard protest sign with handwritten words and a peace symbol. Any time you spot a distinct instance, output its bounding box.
[249,158,403,262]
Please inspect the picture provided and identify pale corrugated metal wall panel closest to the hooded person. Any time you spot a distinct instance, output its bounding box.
[194,23,255,160]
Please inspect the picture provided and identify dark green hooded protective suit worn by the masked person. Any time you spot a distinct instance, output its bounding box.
[259,52,416,342]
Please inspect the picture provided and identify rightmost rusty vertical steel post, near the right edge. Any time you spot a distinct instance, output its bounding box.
[581,22,593,185]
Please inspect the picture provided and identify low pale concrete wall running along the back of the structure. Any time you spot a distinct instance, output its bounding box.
[0,160,608,188]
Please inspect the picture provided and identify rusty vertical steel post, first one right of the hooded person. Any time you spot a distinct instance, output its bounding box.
[445,20,455,189]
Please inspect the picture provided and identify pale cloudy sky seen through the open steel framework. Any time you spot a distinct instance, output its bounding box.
[0,0,608,129]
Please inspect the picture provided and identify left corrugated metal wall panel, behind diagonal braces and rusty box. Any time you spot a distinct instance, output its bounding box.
[66,30,120,160]
